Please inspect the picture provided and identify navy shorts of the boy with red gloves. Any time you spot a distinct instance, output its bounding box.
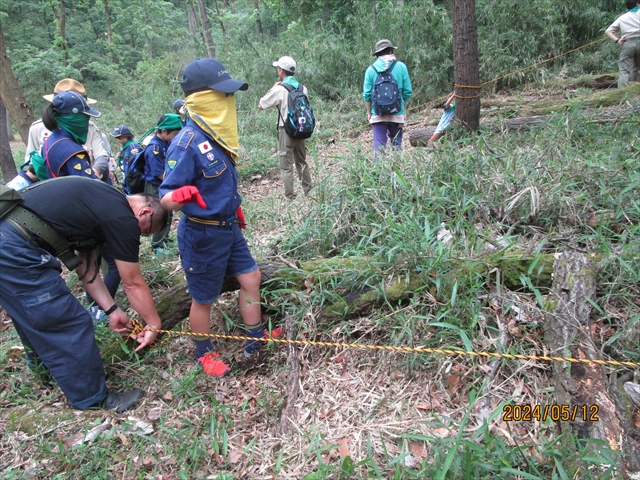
[178,215,258,304]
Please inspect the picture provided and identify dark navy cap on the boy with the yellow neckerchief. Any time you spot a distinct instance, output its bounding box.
[180,58,249,95]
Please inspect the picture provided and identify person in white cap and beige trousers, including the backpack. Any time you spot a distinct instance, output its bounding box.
[258,56,316,200]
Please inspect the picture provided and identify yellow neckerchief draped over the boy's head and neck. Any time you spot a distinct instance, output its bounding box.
[184,90,239,163]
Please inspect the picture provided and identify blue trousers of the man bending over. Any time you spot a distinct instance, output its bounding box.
[0,220,107,410]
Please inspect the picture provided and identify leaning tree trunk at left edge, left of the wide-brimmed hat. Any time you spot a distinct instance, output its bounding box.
[0,25,35,145]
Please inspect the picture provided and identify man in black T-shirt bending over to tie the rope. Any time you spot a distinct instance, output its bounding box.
[0,179,166,413]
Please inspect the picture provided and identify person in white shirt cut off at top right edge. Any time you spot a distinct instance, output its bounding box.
[605,1,640,88]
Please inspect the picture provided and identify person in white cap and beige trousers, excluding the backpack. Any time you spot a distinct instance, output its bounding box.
[258,56,313,199]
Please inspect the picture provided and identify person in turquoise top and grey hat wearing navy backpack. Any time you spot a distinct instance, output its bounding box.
[362,39,413,155]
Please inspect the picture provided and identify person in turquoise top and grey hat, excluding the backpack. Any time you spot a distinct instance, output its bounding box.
[362,39,413,154]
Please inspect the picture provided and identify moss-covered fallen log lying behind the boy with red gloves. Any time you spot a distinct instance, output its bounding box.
[102,253,553,363]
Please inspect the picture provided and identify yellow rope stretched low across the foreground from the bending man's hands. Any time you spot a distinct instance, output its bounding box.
[131,320,640,367]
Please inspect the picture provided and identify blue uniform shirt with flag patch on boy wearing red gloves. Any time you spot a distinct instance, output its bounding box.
[159,120,242,221]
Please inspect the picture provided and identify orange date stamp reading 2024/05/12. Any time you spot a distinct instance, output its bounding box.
[502,405,600,422]
